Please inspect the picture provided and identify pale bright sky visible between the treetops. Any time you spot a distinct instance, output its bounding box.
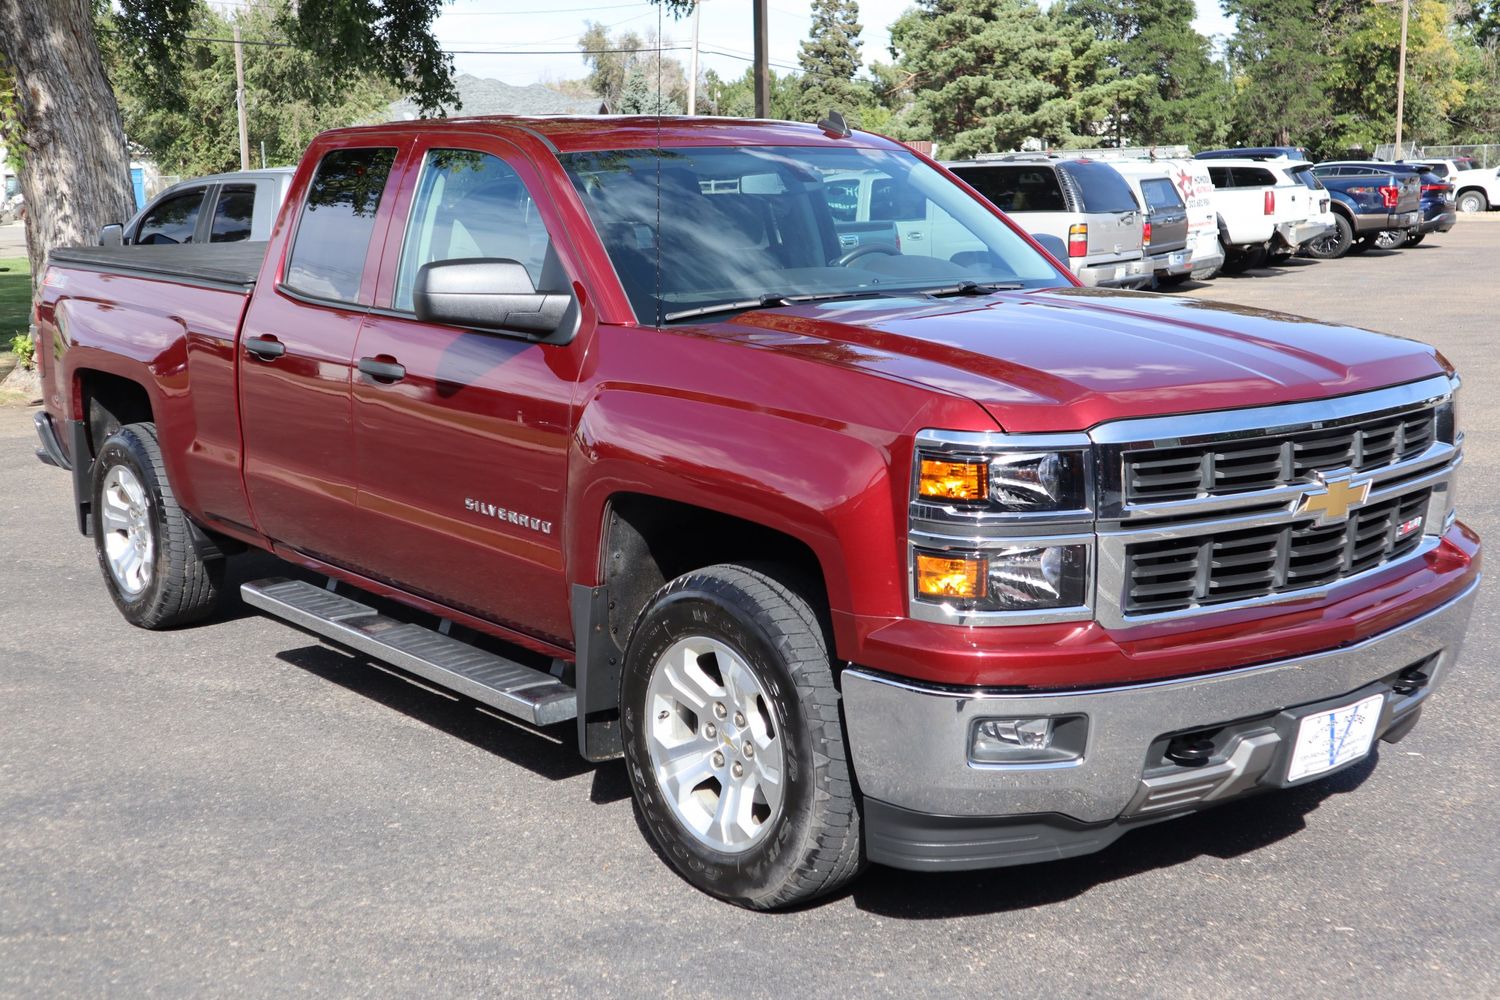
[437,0,1232,84]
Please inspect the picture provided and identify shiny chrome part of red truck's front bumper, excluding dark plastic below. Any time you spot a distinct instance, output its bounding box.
[843,580,1479,833]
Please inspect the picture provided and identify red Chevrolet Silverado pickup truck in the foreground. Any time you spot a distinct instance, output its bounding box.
[36,118,1479,907]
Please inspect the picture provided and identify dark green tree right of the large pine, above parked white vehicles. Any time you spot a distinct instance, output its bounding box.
[1059,0,1230,145]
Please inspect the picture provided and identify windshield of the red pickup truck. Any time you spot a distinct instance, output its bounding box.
[560,145,1068,322]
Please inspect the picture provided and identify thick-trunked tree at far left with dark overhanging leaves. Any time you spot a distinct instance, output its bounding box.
[0,0,458,289]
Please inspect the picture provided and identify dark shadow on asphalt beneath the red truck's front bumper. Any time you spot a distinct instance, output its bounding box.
[846,751,1379,921]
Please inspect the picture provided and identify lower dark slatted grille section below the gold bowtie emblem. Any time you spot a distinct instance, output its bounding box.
[1125,488,1433,615]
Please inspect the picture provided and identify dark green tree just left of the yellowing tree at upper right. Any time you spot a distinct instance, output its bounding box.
[1224,0,1337,145]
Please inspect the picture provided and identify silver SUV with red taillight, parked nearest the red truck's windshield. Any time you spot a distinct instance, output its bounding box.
[945,153,1152,288]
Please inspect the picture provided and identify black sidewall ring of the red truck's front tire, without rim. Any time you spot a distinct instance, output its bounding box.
[620,586,815,901]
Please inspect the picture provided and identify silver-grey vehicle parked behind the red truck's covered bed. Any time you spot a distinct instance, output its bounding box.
[99,166,293,246]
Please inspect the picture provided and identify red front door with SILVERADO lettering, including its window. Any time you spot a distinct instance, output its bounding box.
[353,138,590,643]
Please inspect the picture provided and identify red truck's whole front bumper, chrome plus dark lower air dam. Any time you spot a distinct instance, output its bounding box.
[843,580,1478,868]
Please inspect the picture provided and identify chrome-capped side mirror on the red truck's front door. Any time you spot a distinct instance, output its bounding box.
[411,258,578,343]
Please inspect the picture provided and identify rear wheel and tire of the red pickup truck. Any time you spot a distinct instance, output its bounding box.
[90,423,224,628]
